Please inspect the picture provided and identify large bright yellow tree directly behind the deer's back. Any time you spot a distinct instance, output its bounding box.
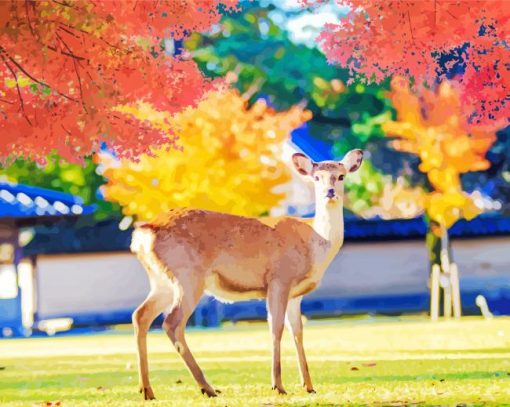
[101,90,311,220]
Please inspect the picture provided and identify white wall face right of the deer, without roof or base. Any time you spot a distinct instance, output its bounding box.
[310,237,510,298]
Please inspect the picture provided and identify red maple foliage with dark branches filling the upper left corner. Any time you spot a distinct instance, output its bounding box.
[0,0,238,162]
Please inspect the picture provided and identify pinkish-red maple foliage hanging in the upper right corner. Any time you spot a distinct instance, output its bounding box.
[308,0,510,126]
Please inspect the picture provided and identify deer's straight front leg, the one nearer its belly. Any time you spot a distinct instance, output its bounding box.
[267,281,290,394]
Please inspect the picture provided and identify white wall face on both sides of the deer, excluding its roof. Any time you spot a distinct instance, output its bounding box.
[33,237,510,318]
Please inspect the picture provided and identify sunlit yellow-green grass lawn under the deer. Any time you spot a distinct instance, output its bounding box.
[0,318,510,406]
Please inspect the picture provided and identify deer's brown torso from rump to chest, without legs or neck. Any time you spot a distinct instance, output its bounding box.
[131,209,318,299]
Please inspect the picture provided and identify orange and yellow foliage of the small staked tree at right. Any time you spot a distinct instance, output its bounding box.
[383,77,496,229]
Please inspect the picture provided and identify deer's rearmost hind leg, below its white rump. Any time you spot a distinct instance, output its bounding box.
[132,289,172,400]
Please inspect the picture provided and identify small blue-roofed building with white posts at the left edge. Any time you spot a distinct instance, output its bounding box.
[0,182,94,336]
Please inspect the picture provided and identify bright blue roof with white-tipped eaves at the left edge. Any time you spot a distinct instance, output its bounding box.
[0,182,95,219]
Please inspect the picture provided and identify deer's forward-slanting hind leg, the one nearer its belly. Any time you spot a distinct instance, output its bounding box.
[163,272,217,397]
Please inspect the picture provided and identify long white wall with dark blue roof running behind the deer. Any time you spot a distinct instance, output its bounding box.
[25,217,510,325]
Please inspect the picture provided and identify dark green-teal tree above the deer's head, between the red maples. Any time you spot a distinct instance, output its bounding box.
[185,1,390,154]
